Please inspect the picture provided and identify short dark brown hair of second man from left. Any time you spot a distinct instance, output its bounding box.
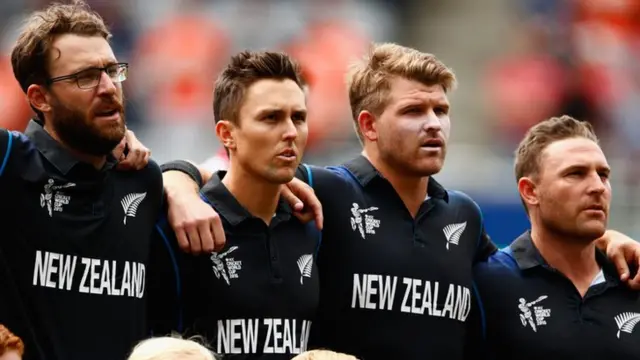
[213,51,304,122]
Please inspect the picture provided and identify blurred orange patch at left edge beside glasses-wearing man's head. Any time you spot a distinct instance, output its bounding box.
[0,56,33,131]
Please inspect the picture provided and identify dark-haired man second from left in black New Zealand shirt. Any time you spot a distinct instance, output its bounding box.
[149,51,320,360]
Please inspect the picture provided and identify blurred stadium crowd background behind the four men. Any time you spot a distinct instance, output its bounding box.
[0,0,640,245]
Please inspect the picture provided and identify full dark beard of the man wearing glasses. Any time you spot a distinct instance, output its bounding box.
[51,94,126,156]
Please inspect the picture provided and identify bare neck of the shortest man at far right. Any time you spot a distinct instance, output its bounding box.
[531,226,600,296]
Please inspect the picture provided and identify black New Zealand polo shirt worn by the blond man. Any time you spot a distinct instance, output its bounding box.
[302,156,495,360]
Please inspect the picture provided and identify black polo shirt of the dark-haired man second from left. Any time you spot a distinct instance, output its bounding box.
[149,172,320,360]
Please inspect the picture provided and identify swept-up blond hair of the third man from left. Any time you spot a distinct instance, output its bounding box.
[347,43,456,141]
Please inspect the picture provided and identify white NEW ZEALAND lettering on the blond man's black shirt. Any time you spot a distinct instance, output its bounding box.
[351,274,471,322]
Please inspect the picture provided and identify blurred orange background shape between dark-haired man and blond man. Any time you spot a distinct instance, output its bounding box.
[286,21,369,146]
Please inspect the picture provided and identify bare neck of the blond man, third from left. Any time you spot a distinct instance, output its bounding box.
[362,150,429,218]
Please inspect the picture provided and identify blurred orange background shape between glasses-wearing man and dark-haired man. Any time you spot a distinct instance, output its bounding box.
[135,14,230,122]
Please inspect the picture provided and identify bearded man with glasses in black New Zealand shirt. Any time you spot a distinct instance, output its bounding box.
[0,3,172,360]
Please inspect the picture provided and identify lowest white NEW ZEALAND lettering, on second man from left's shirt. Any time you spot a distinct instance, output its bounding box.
[217,319,311,354]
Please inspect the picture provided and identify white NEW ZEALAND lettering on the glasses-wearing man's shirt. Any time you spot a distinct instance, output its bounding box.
[32,250,146,299]
